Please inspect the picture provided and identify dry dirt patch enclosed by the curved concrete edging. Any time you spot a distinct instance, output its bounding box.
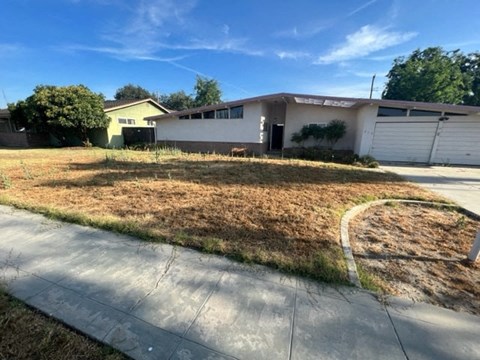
[350,203,480,315]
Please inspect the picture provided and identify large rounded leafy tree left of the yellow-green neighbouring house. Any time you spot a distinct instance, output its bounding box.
[9,85,110,145]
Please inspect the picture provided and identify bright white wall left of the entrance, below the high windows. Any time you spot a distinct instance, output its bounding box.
[157,103,268,143]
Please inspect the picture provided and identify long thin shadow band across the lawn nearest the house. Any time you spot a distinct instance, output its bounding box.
[44,159,405,190]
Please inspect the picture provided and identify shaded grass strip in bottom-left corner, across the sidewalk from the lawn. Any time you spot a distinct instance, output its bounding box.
[0,289,127,360]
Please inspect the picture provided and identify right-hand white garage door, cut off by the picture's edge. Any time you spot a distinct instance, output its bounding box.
[432,121,480,165]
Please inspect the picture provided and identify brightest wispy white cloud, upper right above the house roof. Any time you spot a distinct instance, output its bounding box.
[315,25,417,64]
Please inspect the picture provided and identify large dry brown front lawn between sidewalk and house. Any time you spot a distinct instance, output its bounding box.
[0,149,438,282]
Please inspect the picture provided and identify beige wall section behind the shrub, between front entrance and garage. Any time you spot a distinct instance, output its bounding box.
[284,104,357,150]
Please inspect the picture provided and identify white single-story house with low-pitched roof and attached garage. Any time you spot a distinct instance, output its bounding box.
[145,93,480,165]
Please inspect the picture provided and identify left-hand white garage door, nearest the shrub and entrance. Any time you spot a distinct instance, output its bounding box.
[370,122,438,162]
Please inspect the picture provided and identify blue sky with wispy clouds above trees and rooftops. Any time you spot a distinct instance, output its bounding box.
[0,0,480,108]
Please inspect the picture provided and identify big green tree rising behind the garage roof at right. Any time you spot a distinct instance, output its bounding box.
[382,47,469,104]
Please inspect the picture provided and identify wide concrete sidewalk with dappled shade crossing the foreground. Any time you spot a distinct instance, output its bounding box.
[0,206,480,360]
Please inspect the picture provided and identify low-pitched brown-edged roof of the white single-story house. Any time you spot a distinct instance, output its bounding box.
[145,93,480,120]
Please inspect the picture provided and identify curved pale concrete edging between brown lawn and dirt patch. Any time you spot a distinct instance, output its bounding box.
[340,199,470,288]
